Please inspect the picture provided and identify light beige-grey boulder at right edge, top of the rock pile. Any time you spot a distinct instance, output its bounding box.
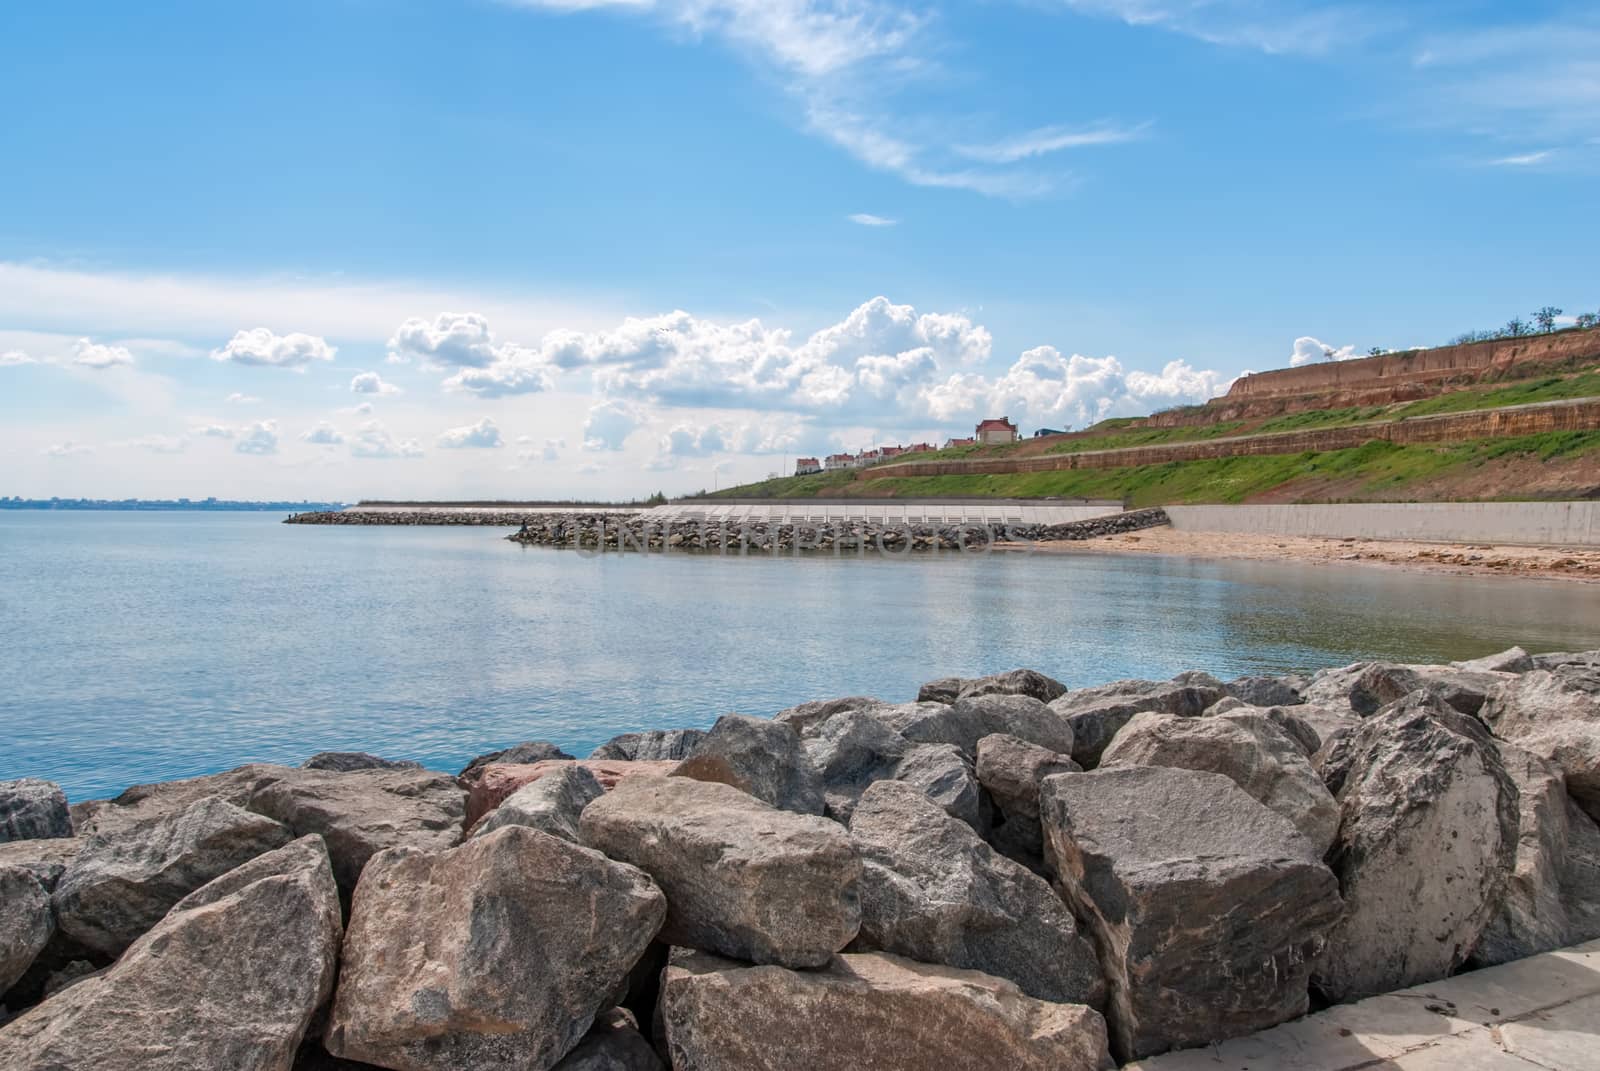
[1480,664,1600,821]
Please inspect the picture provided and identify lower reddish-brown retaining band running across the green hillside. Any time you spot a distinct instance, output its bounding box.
[867,399,1600,477]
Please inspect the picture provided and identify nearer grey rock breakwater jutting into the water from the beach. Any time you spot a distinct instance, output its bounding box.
[507,507,1171,554]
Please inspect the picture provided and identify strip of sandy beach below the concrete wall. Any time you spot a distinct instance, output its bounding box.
[1034,528,1600,583]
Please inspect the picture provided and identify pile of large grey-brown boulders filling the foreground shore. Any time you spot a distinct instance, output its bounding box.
[0,648,1600,1071]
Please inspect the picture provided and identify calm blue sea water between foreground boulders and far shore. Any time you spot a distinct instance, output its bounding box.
[0,512,1600,800]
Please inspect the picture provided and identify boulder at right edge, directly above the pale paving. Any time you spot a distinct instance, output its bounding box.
[1469,744,1600,967]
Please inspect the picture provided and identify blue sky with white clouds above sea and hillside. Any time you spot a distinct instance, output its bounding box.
[0,0,1600,498]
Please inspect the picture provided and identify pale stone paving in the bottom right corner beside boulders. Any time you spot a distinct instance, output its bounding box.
[1130,941,1600,1071]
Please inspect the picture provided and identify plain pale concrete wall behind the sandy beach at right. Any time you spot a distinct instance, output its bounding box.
[1166,501,1600,548]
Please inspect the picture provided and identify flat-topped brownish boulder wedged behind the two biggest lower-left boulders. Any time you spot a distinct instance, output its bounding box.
[246,770,466,895]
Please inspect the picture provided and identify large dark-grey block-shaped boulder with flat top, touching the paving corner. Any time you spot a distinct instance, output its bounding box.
[1040,767,1341,1060]
